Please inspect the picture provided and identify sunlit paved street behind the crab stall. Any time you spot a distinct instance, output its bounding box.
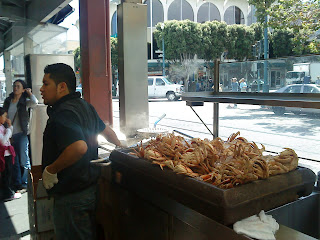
[113,99,320,172]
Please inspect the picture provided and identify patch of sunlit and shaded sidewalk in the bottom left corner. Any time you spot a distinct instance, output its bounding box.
[0,193,30,240]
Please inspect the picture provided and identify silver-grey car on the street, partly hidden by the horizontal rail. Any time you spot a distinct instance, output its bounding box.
[272,84,320,115]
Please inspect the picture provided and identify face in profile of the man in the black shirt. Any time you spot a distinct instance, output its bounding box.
[40,73,59,105]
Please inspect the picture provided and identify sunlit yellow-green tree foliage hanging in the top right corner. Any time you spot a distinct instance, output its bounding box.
[249,0,320,54]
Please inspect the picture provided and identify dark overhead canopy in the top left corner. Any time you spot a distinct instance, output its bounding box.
[0,0,73,55]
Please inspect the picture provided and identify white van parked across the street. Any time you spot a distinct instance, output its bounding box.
[148,76,184,101]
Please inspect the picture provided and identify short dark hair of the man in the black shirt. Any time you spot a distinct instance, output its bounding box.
[44,63,76,93]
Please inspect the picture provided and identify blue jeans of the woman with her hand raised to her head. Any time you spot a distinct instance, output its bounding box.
[12,132,31,187]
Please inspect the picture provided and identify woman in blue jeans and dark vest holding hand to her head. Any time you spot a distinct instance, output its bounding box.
[3,79,38,193]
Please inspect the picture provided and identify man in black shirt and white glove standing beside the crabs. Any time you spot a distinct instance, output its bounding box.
[40,63,121,240]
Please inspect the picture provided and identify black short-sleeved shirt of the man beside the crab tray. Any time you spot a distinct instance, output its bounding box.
[42,93,105,195]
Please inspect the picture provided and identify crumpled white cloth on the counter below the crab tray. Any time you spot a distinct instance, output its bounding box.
[233,210,279,240]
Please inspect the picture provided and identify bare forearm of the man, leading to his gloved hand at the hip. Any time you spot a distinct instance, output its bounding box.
[47,140,88,174]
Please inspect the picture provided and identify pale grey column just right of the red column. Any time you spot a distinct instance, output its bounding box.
[118,2,149,136]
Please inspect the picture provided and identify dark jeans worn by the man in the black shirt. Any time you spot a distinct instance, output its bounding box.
[53,185,98,240]
